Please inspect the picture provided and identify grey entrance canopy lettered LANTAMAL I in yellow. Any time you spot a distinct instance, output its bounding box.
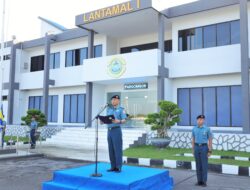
[76,0,170,38]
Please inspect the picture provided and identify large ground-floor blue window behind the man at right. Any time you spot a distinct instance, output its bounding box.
[177,86,242,127]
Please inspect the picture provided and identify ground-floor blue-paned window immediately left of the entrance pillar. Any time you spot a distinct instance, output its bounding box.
[64,94,85,123]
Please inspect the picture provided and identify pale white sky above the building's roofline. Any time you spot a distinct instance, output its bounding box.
[0,0,194,41]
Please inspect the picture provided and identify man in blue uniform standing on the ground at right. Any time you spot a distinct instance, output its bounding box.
[192,115,213,187]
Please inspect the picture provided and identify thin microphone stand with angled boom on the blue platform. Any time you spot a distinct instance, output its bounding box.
[91,105,108,177]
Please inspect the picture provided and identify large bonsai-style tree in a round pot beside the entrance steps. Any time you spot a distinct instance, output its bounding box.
[144,101,182,148]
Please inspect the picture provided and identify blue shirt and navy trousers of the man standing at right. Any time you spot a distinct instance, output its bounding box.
[192,125,212,183]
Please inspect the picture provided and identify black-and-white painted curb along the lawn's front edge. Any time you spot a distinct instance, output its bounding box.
[123,157,250,177]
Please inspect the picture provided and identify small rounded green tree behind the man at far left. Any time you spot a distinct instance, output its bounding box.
[21,109,47,139]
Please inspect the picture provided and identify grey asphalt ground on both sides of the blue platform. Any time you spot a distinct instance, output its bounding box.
[0,157,250,190]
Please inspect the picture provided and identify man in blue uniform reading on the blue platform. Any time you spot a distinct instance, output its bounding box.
[107,95,127,172]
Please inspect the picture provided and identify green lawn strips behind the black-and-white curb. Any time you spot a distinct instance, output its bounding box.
[124,146,250,167]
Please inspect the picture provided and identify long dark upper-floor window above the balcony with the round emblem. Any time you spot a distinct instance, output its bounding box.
[121,40,172,53]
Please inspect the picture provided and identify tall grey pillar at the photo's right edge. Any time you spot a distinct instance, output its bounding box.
[240,0,250,133]
